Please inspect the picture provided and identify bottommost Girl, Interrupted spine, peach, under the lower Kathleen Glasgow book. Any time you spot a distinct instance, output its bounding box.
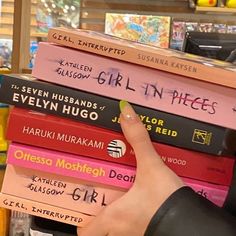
[0,193,94,227]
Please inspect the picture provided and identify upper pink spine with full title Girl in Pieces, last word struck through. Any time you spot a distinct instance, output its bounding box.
[32,43,236,129]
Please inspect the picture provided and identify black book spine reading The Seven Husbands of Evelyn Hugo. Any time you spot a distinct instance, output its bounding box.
[0,75,236,155]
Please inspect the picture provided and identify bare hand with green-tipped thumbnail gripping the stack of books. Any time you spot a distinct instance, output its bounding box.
[78,101,184,236]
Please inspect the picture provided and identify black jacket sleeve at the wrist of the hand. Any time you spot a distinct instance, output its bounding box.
[145,187,236,236]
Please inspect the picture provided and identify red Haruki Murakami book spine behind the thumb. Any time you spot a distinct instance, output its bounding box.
[6,107,235,186]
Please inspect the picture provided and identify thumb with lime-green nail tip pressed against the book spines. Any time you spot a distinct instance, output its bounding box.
[120,100,163,170]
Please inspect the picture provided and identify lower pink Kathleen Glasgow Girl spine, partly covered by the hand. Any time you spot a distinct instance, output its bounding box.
[1,164,125,216]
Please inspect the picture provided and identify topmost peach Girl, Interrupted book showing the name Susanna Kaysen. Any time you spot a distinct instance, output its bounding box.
[48,27,236,88]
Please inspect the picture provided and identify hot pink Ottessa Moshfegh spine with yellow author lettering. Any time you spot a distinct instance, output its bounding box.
[7,143,229,204]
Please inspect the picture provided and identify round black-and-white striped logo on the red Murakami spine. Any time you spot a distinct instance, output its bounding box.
[107,140,126,158]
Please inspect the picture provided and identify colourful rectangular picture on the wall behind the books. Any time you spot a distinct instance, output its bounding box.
[105,13,171,48]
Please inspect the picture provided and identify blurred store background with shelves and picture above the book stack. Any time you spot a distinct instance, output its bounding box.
[0,0,236,70]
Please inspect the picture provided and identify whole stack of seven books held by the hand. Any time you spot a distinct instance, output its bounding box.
[0,28,236,230]
